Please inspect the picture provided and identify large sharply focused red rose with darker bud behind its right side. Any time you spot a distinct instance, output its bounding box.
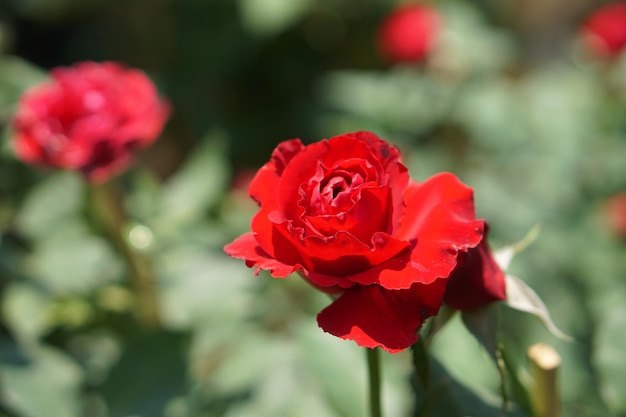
[224,132,504,352]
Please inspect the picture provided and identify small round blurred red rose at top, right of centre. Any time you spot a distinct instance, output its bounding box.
[378,4,441,63]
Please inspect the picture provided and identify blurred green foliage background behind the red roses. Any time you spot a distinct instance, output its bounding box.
[0,0,626,417]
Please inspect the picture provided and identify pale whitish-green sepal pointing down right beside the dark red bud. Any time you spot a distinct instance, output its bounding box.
[505,275,572,341]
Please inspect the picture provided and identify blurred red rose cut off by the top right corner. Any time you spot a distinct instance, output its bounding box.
[582,3,626,58]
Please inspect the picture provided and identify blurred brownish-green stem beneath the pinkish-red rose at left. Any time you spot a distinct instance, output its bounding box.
[90,184,161,328]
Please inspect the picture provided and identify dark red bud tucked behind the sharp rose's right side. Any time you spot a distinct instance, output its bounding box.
[443,224,506,310]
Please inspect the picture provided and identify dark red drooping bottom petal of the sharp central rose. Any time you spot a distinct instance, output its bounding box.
[317,280,445,353]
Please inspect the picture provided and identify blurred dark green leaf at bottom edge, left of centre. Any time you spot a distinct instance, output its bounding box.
[101,332,188,417]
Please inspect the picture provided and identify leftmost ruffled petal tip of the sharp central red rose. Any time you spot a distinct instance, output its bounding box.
[224,233,301,278]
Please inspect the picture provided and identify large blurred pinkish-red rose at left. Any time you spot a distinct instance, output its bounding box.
[13,62,169,182]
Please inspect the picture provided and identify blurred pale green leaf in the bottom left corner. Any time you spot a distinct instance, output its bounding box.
[0,338,83,417]
